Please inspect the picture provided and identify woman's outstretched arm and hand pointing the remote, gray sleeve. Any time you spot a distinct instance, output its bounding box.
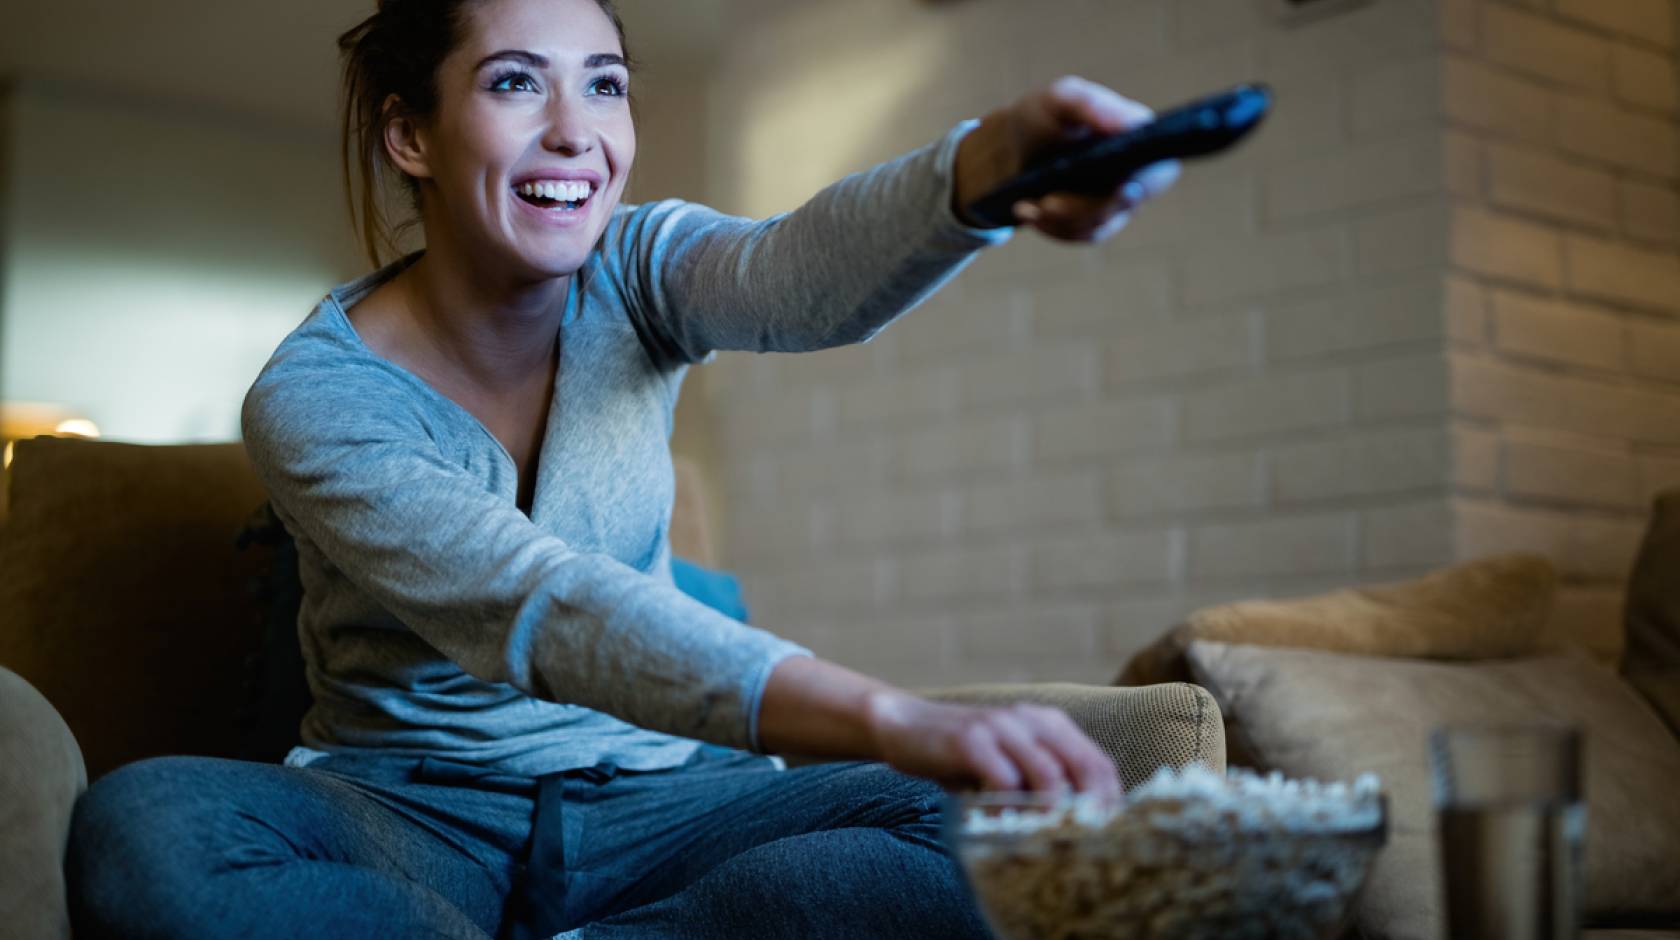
[614,77,1178,363]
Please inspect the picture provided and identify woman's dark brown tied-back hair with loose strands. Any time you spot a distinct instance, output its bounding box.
[338,0,635,267]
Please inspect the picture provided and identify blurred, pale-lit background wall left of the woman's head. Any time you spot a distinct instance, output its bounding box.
[0,81,363,441]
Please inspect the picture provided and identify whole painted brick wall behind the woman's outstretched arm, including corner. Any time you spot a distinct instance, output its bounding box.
[638,0,1680,685]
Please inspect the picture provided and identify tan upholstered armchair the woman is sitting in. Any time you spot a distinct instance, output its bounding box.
[0,438,1225,940]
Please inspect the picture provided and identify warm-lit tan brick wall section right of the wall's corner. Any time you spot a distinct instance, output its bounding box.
[1436,0,1680,656]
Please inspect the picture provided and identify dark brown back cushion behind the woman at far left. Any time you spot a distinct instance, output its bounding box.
[0,438,267,779]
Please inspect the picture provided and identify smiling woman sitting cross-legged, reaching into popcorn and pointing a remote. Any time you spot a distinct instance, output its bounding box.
[66,0,1169,940]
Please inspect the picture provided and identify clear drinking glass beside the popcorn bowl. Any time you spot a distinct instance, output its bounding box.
[1430,725,1586,940]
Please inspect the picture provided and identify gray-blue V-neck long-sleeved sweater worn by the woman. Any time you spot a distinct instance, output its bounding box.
[240,121,1013,776]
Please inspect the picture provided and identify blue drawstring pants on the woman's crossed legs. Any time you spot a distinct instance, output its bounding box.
[66,745,988,940]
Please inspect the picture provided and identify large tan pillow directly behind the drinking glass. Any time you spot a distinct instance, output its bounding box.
[1188,641,1680,940]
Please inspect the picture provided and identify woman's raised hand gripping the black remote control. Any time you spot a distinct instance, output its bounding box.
[953,76,1179,242]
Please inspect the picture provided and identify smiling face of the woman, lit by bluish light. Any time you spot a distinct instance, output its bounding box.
[420,0,635,279]
